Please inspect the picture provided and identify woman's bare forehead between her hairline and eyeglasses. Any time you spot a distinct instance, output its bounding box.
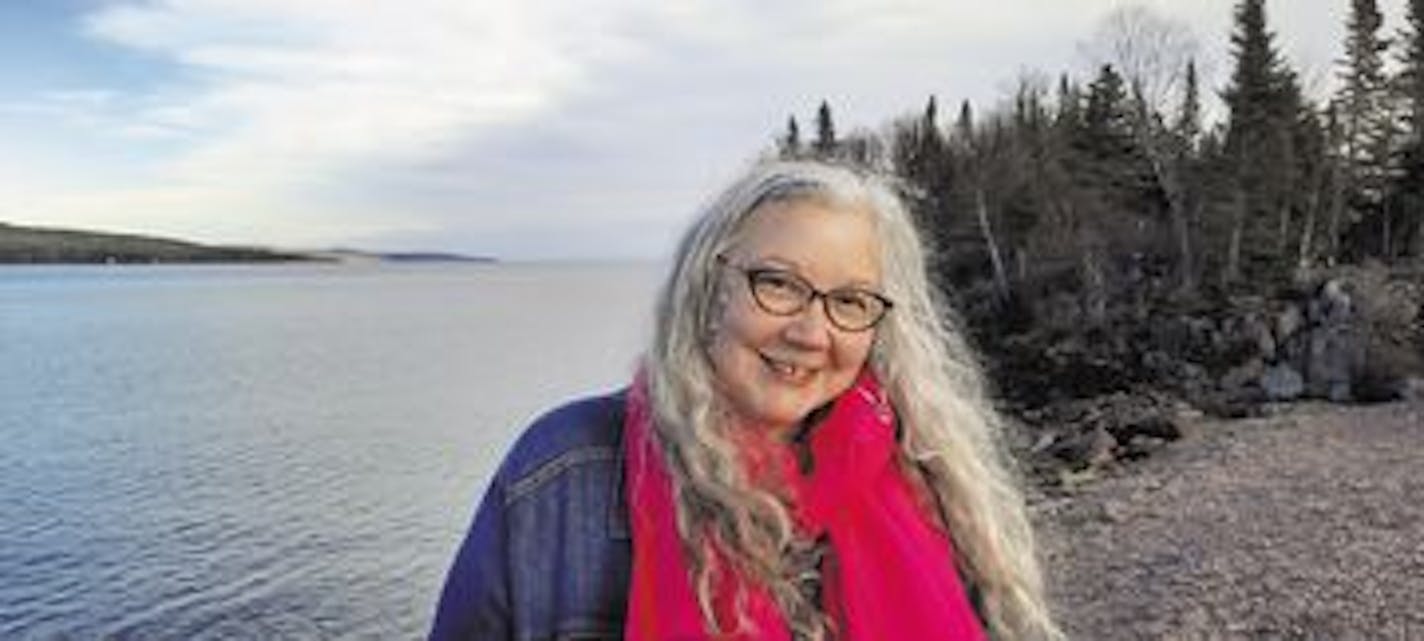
[738,199,880,285]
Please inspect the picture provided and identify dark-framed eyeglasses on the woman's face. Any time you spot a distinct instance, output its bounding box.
[716,255,894,332]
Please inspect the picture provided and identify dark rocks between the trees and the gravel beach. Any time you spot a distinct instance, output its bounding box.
[970,268,1424,478]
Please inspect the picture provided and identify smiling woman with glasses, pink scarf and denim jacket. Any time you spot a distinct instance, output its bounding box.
[431,162,1059,641]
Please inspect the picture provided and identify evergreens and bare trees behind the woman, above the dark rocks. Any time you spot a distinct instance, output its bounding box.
[775,0,1424,318]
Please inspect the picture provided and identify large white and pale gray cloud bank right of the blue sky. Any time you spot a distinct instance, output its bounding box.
[48,0,1099,251]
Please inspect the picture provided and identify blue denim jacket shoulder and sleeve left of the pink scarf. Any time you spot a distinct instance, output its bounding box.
[430,392,632,641]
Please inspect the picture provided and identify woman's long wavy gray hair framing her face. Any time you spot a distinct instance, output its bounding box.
[644,161,1062,641]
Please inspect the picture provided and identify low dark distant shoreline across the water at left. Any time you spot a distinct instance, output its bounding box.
[0,222,497,265]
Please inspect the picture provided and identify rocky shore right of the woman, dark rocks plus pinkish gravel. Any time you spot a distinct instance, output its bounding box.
[964,265,1424,641]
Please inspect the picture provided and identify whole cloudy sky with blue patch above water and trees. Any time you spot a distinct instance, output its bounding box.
[0,0,1404,259]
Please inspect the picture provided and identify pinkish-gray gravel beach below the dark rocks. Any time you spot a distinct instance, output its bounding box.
[1032,402,1424,641]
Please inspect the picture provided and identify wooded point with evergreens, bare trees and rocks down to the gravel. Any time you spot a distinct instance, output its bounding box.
[769,0,1424,464]
